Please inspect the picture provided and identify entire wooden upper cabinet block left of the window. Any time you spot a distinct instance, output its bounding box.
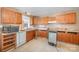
[1,8,22,24]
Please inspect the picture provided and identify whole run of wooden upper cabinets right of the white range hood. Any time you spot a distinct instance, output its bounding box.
[56,12,76,24]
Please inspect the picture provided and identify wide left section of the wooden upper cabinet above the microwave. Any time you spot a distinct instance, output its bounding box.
[2,8,16,24]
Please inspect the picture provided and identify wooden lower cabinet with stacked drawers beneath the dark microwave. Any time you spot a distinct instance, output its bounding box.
[0,33,16,51]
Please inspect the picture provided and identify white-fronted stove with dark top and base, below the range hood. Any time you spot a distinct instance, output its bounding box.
[48,31,57,46]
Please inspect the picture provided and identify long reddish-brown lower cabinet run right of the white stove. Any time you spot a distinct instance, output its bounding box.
[57,32,79,44]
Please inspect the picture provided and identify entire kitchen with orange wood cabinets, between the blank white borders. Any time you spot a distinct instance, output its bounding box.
[0,7,79,52]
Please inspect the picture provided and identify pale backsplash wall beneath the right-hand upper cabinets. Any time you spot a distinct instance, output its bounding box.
[48,24,79,30]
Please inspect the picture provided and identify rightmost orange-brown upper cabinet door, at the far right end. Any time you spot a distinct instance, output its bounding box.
[65,13,76,23]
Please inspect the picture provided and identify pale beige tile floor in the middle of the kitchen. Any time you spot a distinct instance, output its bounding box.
[10,38,79,52]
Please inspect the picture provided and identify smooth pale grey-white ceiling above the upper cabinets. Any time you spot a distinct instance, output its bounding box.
[14,7,79,16]
